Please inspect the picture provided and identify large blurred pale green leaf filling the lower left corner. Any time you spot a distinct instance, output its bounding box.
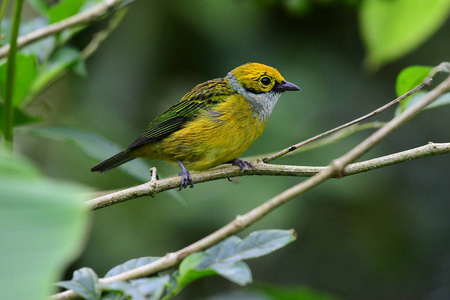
[0,153,89,299]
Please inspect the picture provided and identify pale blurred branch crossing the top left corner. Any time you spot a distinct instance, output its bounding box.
[0,0,123,58]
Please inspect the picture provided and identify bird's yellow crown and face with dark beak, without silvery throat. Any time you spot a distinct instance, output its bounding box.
[228,63,300,94]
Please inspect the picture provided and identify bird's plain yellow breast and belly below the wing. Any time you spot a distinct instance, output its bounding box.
[140,94,267,170]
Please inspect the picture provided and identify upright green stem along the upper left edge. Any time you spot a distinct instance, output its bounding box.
[3,0,23,150]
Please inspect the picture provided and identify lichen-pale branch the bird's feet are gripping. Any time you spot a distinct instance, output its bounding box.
[86,143,450,210]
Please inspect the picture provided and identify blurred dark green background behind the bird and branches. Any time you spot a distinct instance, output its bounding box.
[17,0,450,299]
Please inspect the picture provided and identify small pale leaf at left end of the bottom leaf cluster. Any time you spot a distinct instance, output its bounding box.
[56,268,102,300]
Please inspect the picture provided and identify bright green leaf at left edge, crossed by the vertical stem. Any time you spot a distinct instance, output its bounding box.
[0,52,37,107]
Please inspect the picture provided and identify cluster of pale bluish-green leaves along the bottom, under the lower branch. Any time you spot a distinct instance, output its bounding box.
[58,230,296,300]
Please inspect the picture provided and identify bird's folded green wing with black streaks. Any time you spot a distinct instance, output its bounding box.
[128,78,235,149]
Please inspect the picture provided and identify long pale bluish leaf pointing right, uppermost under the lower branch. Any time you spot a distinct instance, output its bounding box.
[197,229,296,269]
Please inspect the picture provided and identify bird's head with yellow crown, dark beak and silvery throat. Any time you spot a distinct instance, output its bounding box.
[226,63,300,122]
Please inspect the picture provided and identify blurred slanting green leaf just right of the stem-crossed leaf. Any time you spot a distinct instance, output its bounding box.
[30,47,82,97]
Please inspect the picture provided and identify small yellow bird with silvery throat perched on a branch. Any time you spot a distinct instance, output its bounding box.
[91,63,300,190]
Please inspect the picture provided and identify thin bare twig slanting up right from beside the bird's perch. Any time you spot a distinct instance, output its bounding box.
[263,78,432,163]
